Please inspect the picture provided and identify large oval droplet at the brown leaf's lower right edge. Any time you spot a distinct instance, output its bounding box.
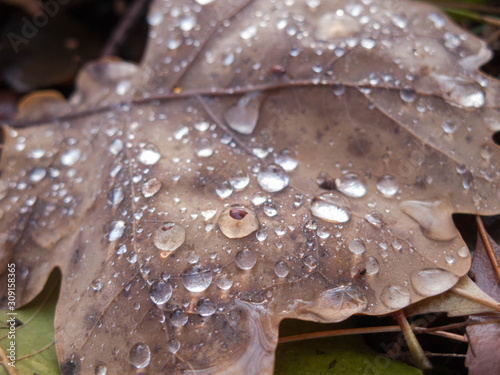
[410,268,458,296]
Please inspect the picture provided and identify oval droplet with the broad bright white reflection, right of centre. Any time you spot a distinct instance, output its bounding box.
[311,193,351,223]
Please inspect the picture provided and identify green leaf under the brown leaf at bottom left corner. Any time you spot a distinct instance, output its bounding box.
[0,272,61,375]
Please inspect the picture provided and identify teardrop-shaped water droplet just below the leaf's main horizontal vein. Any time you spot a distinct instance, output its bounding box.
[224,93,260,135]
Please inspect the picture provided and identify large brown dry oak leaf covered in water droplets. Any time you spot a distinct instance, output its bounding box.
[0,0,500,374]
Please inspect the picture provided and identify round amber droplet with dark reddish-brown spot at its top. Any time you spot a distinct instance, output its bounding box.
[217,205,259,238]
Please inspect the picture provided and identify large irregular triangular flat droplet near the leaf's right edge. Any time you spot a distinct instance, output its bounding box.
[399,200,458,241]
